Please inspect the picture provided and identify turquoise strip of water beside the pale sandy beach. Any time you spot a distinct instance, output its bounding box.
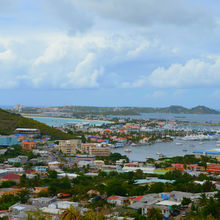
[28,117,107,127]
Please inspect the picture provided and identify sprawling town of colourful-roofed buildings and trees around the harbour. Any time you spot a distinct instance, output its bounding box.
[0,119,220,220]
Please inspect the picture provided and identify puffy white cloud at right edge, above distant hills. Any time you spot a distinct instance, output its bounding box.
[148,57,220,88]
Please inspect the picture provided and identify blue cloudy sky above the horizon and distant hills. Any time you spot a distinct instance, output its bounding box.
[0,0,220,109]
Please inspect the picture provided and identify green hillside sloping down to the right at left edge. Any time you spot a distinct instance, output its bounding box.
[0,109,73,139]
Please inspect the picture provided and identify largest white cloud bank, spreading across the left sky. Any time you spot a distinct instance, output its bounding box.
[0,33,156,89]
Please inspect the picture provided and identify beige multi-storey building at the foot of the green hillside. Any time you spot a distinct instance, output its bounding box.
[59,139,82,156]
